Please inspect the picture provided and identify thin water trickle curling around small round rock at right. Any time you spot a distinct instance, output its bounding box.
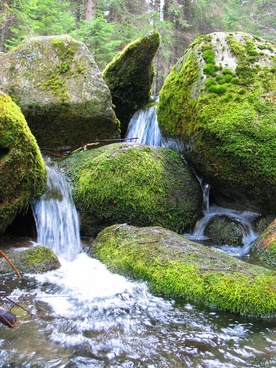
[185,178,258,257]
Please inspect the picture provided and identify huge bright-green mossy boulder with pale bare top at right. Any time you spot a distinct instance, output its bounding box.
[158,32,276,213]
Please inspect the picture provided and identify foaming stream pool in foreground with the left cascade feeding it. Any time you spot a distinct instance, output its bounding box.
[0,108,276,368]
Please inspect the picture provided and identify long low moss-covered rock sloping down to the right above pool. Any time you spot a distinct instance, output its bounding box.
[95,225,276,318]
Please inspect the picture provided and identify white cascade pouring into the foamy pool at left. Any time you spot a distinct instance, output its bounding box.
[32,162,81,260]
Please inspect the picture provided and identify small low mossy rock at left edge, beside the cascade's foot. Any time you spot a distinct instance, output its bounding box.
[0,245,60,275]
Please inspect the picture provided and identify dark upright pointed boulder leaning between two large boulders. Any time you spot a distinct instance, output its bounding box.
[103,32,160,136]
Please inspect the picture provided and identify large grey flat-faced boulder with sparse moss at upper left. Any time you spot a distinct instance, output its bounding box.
[0,35,120,149]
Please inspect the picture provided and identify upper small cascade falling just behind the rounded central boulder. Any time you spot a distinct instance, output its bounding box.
[126,105,162,146]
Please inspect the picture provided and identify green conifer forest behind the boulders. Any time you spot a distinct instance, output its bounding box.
[0,0,276,94]
